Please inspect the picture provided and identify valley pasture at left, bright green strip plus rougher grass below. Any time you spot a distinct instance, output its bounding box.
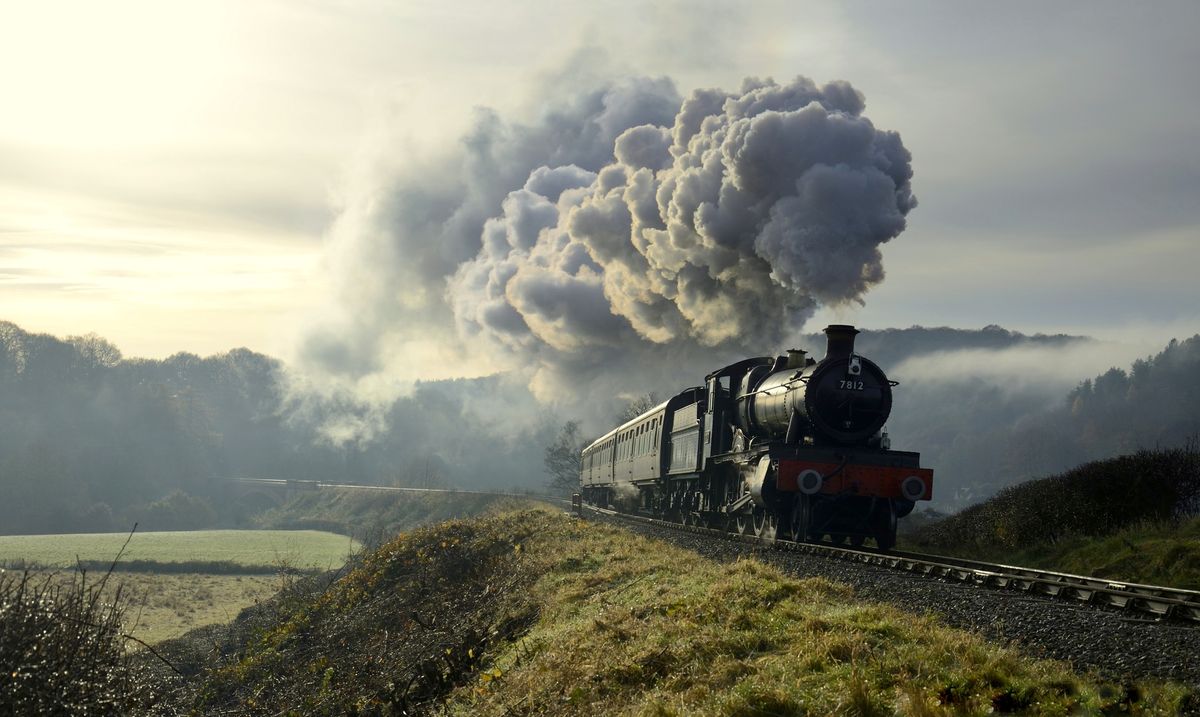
[0,530,358,644]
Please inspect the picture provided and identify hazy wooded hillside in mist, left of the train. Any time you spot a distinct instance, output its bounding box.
[0,323,557,534]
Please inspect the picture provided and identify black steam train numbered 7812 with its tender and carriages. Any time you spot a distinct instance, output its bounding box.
[580,325,934,550]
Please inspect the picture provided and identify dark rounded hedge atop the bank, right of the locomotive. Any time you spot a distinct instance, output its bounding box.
[913,447,1200,552]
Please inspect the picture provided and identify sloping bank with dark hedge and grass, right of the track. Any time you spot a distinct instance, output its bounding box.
[902,450,1200,590]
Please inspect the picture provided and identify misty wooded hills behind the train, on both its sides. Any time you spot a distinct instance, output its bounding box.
[0,323,1200,534]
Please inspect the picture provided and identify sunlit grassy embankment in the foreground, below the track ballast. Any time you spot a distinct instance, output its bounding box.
[180,510,1196,716]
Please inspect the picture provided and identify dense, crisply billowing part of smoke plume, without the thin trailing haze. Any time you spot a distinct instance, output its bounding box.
[446,78,916,405]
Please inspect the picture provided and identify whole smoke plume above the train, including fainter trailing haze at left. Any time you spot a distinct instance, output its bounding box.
[306,77,917,424]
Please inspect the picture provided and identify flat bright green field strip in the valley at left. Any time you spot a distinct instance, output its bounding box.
[0,530,359,570]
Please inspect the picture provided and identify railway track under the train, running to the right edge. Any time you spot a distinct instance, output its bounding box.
[583,504,1200,626]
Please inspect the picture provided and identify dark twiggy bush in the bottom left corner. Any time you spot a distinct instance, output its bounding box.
[0,571,165,715]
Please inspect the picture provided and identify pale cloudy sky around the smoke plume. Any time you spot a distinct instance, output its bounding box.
[0,0,1200,369]
